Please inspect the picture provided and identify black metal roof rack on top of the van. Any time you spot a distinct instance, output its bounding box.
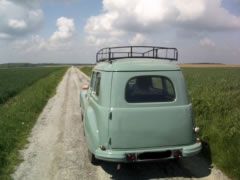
[96,46,178,63]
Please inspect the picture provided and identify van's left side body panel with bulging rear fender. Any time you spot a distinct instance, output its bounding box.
[80,72,112,151]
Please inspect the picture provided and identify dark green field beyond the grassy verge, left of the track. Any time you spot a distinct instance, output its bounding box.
[0,67,62,105]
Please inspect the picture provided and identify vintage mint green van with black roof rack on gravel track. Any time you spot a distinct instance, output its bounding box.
[80,46,201,163]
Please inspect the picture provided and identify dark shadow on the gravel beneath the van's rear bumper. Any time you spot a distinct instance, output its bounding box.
[99,144,212,180]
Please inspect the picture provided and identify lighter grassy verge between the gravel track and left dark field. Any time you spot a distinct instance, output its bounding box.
[0,68,66,179]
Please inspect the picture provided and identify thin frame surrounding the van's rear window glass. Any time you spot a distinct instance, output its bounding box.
[124,75,177,104]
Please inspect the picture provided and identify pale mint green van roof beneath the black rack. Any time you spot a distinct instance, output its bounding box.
[94,58,180,72]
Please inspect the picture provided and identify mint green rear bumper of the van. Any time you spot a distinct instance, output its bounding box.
[94,142,202,162]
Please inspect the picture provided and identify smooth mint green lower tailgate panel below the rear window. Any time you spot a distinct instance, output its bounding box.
[109,105,193,149]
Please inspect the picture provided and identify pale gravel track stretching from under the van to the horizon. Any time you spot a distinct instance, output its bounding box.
[13,67,227,180]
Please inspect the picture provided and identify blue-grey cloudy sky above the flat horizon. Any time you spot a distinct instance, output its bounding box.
[0,0,240,64]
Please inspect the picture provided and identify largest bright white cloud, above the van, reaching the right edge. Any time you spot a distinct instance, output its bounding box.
[85,0,240,43]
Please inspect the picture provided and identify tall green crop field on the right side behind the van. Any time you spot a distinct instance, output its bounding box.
[81,67,240,179]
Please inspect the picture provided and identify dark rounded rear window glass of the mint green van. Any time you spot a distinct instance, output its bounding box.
[125,76,176,103]
